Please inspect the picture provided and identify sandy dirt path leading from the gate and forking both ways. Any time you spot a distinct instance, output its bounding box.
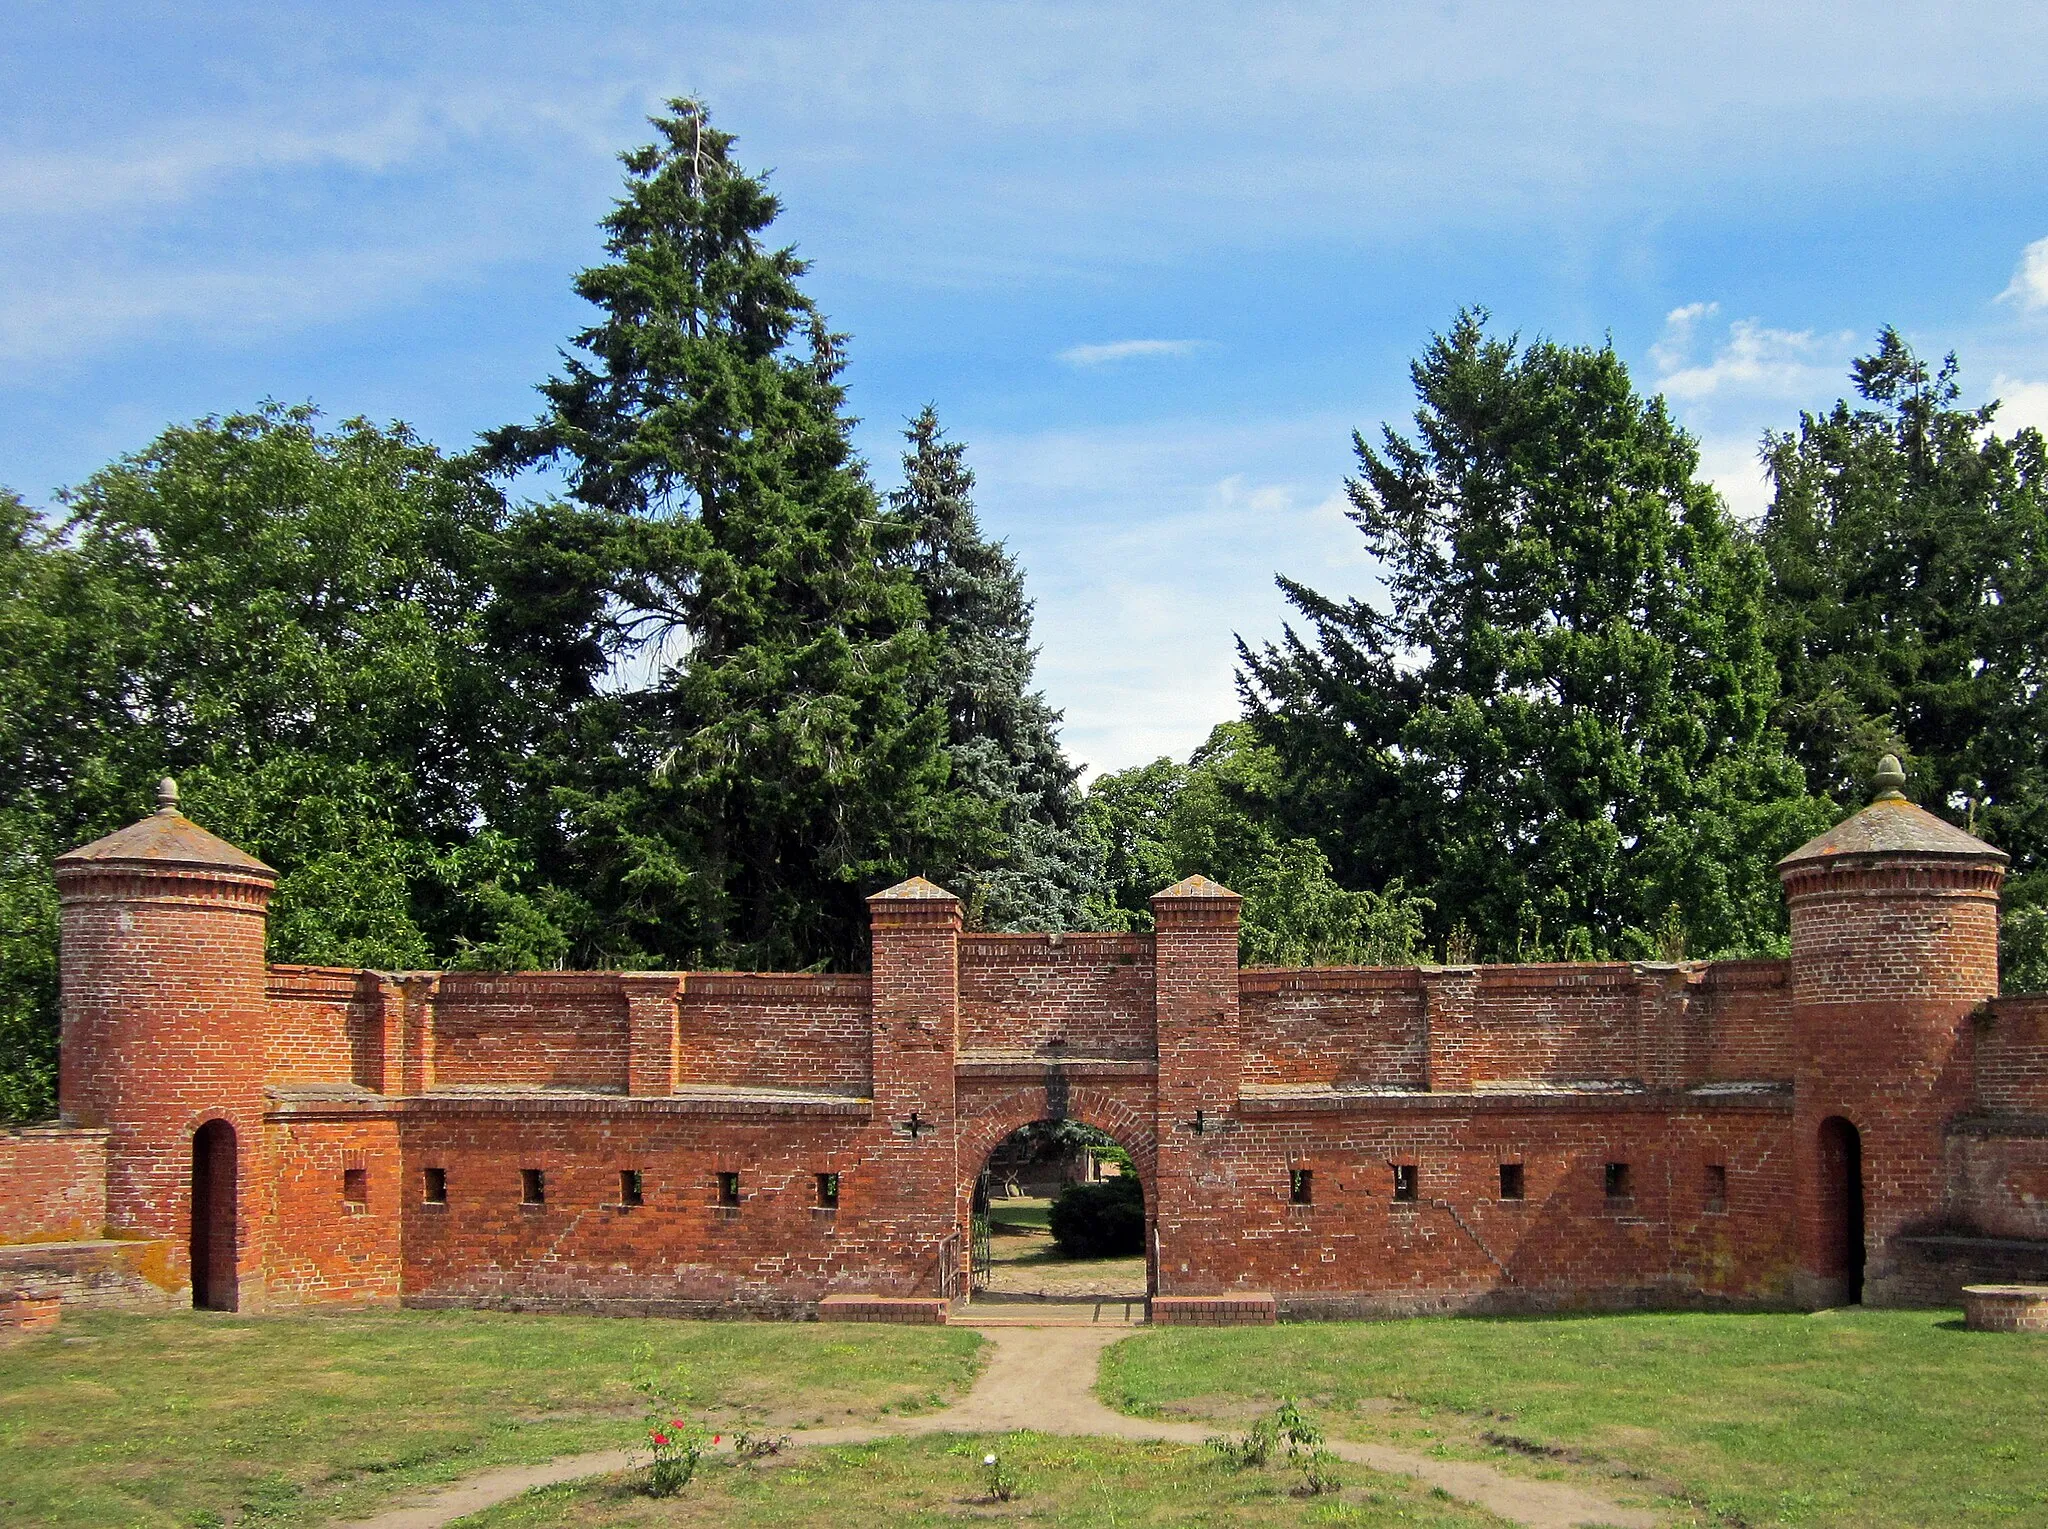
[360,1326,1663,1529]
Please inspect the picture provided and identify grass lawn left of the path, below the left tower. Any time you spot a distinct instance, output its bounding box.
[0,1312,979,1529]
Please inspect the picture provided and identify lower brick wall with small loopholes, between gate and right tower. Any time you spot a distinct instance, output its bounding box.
[1196,1095,1794,1316]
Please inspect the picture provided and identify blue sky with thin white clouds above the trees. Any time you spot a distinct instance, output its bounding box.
[0,0,2048,768]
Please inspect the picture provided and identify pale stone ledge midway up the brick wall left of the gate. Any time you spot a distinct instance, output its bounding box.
[266,1085,874,1120]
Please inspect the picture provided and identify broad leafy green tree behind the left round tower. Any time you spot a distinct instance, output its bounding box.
[0,405,569,1118]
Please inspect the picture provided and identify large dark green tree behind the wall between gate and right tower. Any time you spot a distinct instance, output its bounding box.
[1239,311,1827,958]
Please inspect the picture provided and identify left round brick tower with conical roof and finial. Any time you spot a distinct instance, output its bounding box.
[55,780,276,1310]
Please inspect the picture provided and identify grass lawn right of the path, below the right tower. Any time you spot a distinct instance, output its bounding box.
[1102,1310,2048,1527]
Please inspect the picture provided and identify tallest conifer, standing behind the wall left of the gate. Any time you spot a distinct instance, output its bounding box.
[485,100,954,964]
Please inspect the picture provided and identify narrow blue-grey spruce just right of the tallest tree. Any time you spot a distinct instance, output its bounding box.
[889,405,1100,929]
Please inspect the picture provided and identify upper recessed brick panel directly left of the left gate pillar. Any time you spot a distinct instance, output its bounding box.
[676,972,874,1093]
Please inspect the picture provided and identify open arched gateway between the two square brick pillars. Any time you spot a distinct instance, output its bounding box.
[971,1120,1151,1306]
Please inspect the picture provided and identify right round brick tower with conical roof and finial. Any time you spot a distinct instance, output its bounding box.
[1778,755,2007,1306]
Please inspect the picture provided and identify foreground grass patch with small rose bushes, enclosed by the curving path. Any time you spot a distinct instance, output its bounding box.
[463,1433,1505,1529]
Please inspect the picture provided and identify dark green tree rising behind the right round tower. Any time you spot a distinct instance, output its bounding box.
[1761,330,2048,980]
